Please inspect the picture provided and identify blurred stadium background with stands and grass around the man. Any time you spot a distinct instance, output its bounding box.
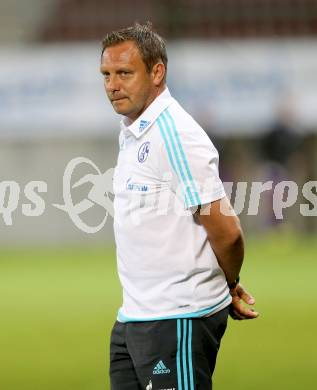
[0,0,317,390]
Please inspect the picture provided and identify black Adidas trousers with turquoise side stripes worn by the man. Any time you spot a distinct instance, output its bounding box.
[110,307,229,390]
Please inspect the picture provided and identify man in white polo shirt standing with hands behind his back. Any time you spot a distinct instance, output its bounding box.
[101,24,258,390]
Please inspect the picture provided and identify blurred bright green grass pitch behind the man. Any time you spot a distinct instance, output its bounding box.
[0,234,317,390]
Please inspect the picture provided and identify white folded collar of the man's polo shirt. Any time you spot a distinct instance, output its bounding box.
[120,87,173,138]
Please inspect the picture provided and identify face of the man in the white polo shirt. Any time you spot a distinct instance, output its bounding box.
[100,41,157,121]
